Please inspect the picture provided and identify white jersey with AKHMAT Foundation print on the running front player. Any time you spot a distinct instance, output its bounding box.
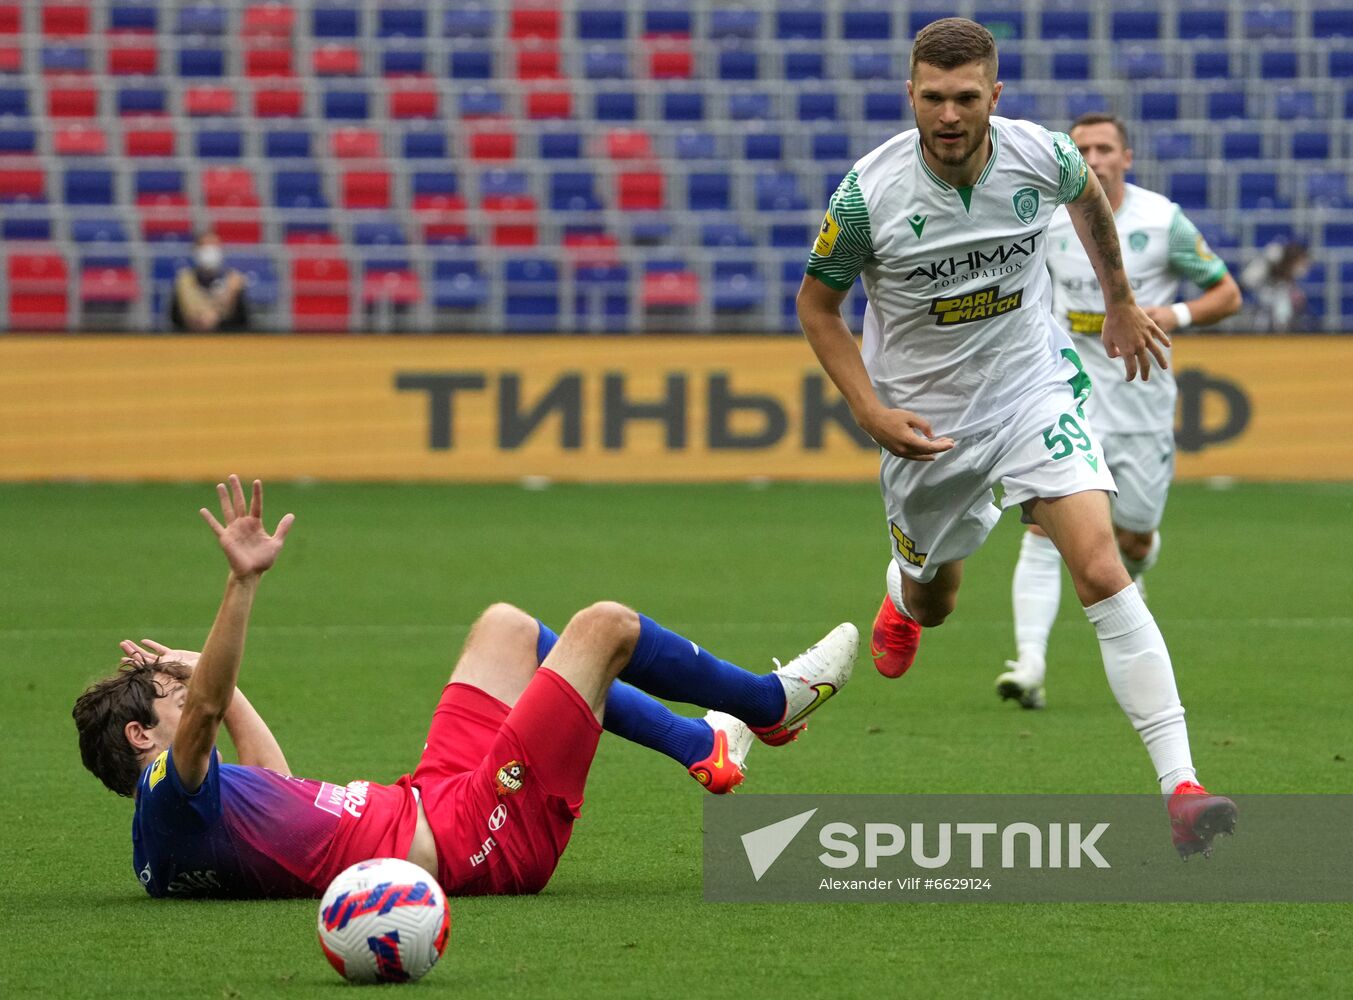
[808,118,1088,437]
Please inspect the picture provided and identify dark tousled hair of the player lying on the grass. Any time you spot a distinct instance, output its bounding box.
[70,660,192,798]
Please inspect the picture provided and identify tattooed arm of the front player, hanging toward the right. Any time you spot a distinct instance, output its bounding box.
[1066,173,1170,382]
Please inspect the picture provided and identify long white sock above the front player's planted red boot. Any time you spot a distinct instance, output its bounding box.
[1085,586,1197,794]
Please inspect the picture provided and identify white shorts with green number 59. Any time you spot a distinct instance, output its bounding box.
[879,386,1116,583]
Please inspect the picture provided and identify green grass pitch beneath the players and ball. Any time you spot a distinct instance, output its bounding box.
[0,481,1353,1000]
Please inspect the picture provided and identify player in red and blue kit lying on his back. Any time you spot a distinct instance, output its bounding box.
[73,476,859,897]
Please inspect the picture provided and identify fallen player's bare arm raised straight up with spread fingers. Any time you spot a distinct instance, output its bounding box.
[173,475,295,792]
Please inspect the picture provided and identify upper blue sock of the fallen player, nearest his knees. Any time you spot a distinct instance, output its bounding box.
[620,614,785,725]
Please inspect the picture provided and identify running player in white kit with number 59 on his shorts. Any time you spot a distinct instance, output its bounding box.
[798,18,1235,855]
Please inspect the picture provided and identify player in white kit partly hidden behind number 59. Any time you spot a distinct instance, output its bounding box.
[996,112,1241,708]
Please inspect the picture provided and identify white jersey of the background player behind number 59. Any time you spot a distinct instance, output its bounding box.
[1047,184,1226,434]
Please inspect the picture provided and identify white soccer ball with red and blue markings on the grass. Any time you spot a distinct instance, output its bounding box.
[319,858,451,982]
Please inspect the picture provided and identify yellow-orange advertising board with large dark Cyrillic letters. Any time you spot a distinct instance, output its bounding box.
[0,336,1353,482]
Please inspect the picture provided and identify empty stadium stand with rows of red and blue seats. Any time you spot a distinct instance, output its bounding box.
[0,0,1353,332]
